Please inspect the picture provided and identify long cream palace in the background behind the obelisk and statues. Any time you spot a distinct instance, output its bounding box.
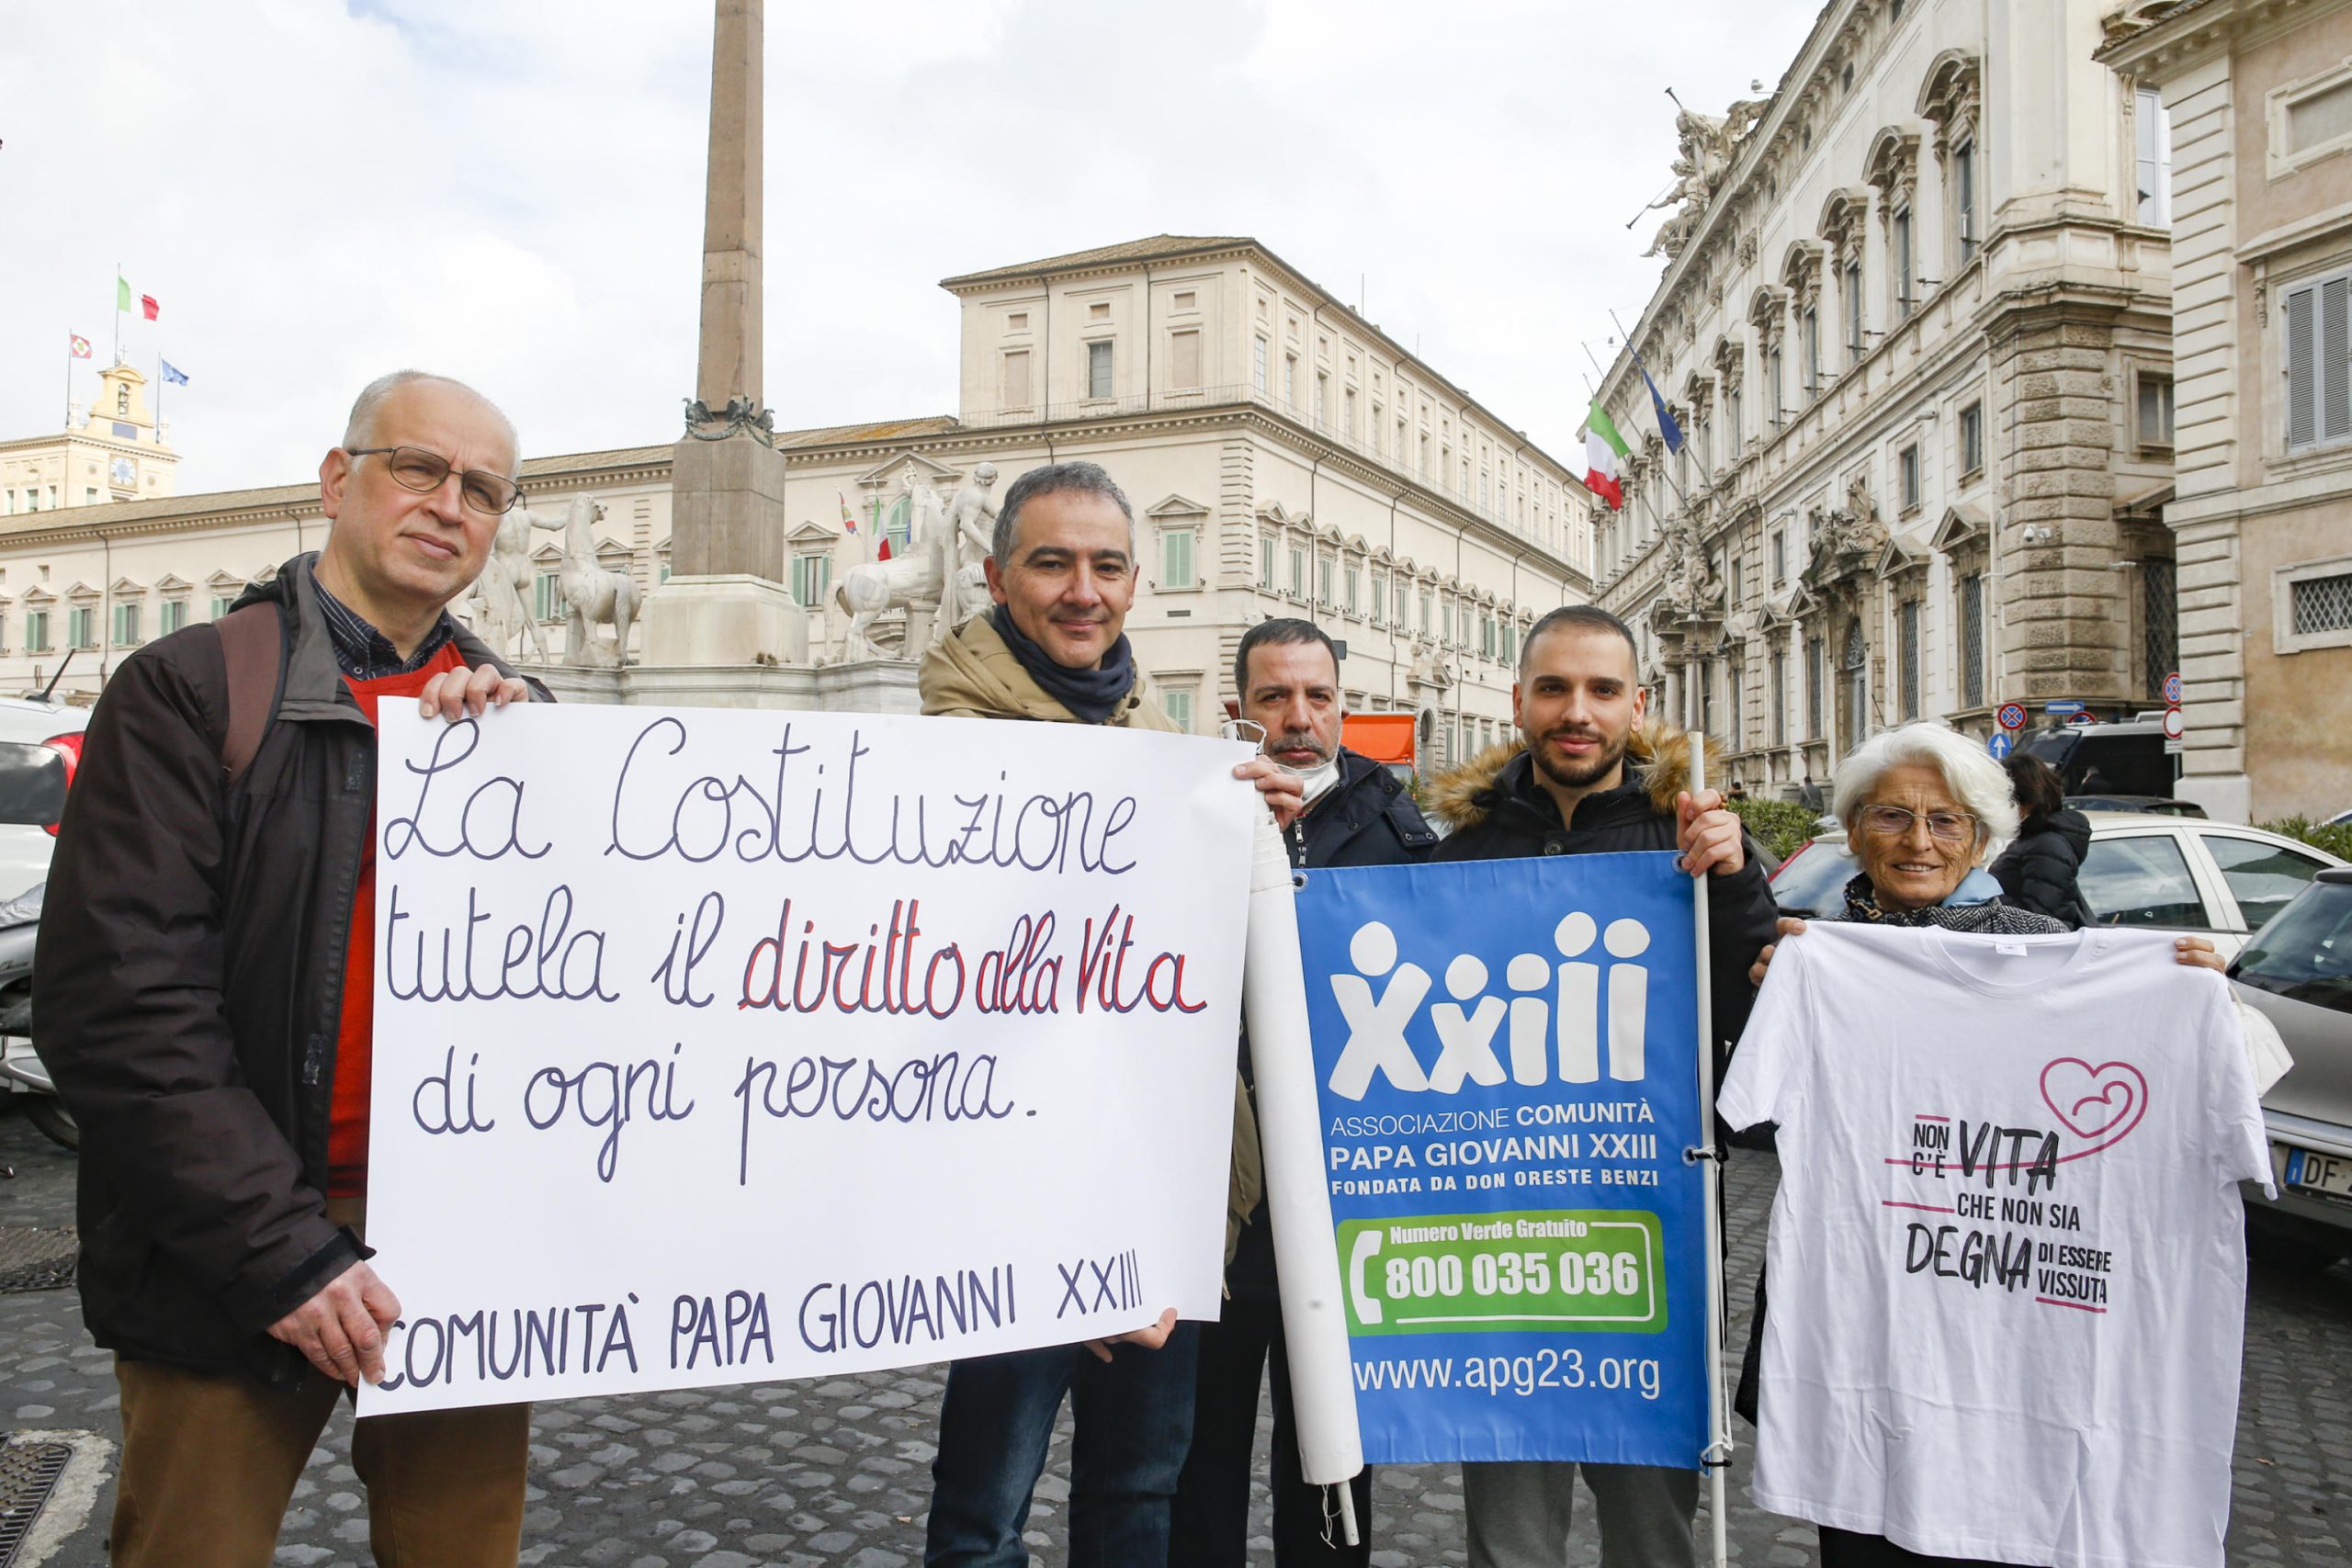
[0,235,1595,761]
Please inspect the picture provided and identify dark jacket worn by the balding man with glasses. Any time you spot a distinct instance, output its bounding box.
[33,555,548,1382]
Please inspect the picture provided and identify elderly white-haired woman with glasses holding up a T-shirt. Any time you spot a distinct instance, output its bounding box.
[1734,722,2222,1568]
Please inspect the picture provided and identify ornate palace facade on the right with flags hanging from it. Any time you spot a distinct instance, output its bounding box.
[1597,0,2178,795]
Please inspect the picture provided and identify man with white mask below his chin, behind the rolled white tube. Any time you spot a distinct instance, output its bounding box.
[1169,621,1437,1568]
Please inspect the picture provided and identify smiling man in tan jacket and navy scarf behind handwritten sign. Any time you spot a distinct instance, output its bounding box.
[917,463,1298,1568]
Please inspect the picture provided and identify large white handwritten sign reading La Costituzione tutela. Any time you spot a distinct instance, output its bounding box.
[360,703,1261,1416]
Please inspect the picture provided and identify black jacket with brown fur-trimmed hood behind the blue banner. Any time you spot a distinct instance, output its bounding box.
[1435,731,1781,1069]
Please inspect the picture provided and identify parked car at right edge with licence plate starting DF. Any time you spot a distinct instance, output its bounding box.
[2230,867,2352,1267]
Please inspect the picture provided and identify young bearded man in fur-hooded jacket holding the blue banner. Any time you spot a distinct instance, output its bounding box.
[1435,604,1776,1568]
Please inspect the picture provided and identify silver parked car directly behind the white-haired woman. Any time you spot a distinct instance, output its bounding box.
[1771,811,2343,959]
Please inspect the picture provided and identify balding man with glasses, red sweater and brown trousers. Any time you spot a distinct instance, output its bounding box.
[35,371,546,1568]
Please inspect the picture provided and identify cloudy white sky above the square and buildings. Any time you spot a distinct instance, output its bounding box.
[0,0,1815,493]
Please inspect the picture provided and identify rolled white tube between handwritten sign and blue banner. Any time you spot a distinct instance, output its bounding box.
[1242,811,1364,1547]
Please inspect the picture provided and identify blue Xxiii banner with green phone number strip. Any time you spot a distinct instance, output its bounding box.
[1298,853,1708,1470]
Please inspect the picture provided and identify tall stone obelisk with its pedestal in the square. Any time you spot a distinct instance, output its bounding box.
[644,0,809,668]
